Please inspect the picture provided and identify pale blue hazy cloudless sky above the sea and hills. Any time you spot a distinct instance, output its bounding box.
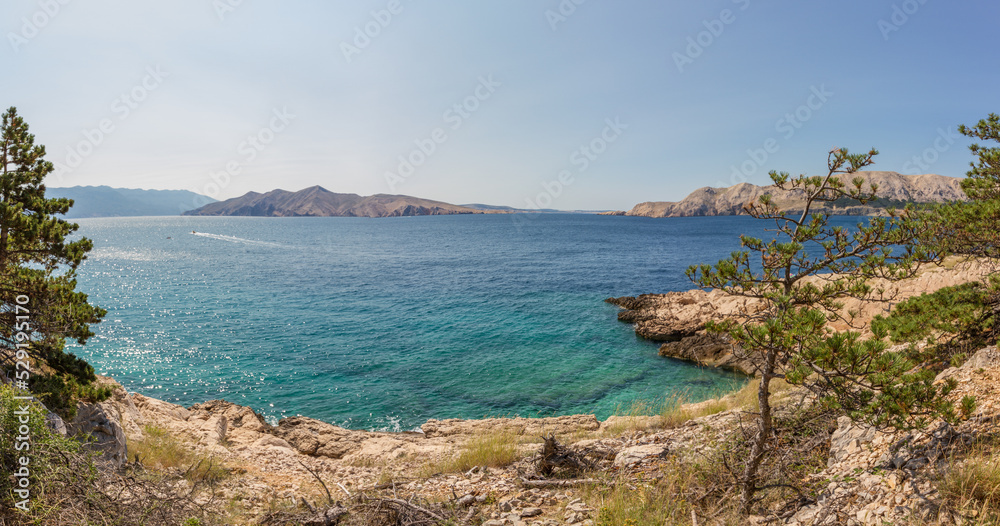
[0,0,1000,209]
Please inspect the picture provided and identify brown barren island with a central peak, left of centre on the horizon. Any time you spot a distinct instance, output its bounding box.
[184,186,503,217]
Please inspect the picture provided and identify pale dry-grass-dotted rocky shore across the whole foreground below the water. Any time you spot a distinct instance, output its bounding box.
[56,347,1000,526]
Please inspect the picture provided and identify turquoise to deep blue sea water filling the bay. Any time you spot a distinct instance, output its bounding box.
[73,214,784,430]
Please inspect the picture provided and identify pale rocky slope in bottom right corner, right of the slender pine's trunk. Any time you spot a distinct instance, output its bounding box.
[785,347,1000,526]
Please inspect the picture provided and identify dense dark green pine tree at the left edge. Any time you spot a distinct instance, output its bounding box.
[0,108,105,400]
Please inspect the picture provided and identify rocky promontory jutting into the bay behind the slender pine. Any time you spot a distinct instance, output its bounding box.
[605,262,985,376]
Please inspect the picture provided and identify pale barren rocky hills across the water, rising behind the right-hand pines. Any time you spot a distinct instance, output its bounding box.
[603,172,967,217]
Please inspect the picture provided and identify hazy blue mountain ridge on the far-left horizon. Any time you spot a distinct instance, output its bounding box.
[47,186,215,219]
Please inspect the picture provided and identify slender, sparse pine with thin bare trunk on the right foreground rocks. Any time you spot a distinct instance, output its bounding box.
[688,149,954,514]
